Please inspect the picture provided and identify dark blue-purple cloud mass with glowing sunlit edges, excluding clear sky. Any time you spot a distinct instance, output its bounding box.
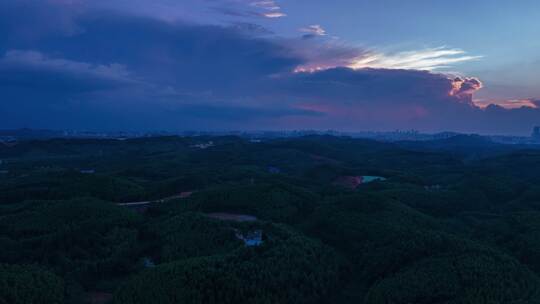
[0,0,540,134]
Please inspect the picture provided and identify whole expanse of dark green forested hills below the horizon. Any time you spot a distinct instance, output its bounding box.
[0,136,540,304]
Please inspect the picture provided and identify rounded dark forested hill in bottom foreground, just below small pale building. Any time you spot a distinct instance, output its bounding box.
[115,225,340,304]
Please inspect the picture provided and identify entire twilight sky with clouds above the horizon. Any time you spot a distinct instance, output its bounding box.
[0,0,540,135]
